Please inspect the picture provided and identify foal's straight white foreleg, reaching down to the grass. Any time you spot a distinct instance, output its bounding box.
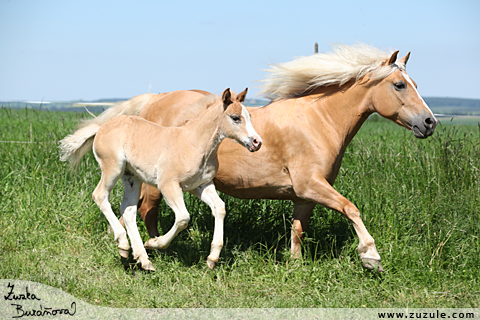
[191,182,225,269]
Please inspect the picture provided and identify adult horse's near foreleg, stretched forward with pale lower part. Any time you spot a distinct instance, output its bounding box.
[294,176,383,271]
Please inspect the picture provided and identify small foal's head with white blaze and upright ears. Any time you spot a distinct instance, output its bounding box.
[222,88,262,152]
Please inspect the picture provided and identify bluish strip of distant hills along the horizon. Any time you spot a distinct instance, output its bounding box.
[0,97,480,116]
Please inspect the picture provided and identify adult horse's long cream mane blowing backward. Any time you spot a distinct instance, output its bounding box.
[260,43,395,101]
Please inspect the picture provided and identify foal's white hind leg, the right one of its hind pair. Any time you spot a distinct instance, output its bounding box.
[120,174,155,271]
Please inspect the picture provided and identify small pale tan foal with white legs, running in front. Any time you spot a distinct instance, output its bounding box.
[62,89,262,270]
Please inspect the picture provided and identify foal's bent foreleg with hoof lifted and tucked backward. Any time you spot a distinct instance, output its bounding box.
[148,182,190,249]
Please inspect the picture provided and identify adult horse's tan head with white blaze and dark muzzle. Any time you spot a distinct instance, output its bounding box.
[372,51,437,139]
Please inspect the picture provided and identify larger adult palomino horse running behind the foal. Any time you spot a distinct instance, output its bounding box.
[60,44,437,270]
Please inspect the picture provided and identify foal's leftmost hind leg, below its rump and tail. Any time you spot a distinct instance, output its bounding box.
[92,161,130,258]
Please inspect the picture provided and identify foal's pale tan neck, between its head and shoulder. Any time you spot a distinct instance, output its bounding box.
[185,103,225,160]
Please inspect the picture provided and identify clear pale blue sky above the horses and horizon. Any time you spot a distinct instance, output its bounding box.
[0,0,480,101]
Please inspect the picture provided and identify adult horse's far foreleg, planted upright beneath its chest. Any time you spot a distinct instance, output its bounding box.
[291,202,316,259]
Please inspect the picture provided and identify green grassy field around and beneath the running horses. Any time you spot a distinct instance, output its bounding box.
[0,108,480,308]
